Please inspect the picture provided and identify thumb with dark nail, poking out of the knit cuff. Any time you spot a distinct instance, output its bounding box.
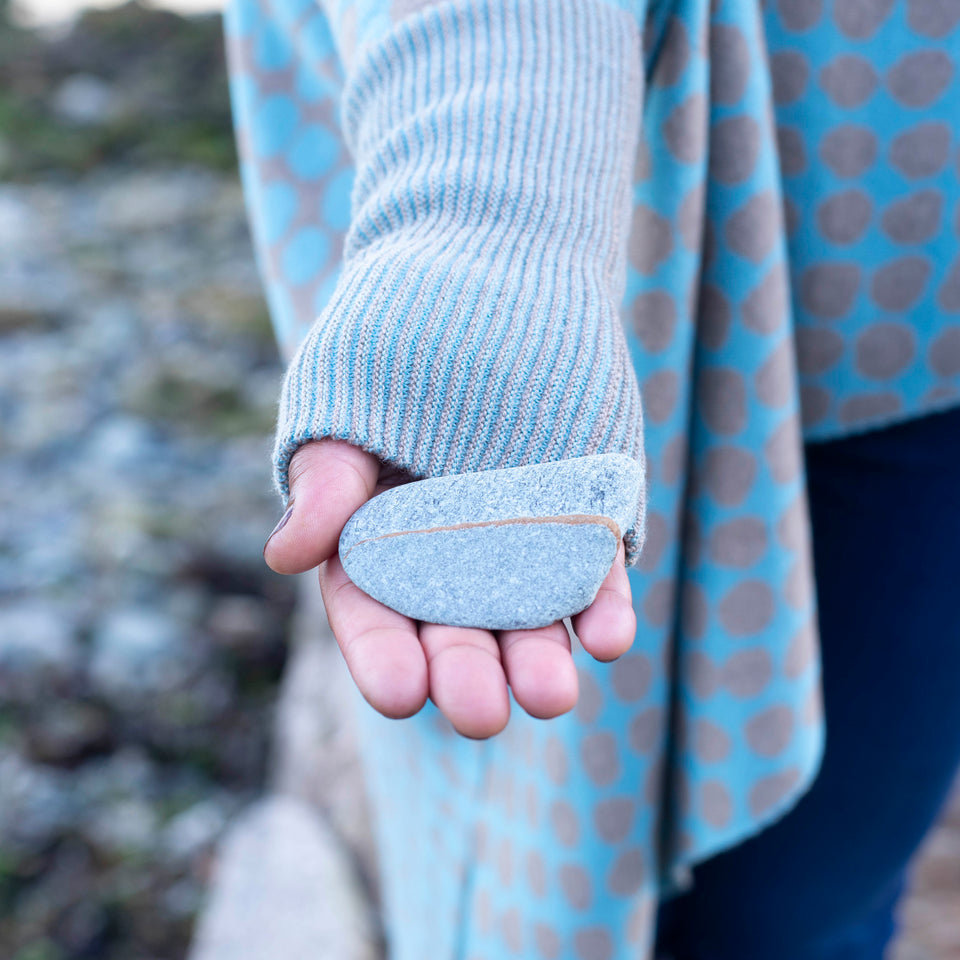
[263,438,380,573]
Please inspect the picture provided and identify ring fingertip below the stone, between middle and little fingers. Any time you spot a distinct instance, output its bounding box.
[499,621,579,720]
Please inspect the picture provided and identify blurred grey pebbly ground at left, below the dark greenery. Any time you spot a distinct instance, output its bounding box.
[0,167,293,960]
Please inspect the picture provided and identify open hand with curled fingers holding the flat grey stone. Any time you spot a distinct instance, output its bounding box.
[264,439,637,739]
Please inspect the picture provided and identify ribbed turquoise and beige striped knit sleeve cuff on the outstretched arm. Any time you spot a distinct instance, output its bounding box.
[274,0,643,563]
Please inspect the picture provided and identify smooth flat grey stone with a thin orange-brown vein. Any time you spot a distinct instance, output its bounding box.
[340,454,643,630]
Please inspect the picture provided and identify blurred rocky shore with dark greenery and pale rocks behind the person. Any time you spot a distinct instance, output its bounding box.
[0,0,960,960]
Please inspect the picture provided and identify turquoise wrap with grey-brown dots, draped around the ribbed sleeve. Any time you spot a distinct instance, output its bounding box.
[226,0,960,960]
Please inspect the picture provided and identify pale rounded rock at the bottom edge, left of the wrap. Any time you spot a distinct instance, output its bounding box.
[190,797,379,960]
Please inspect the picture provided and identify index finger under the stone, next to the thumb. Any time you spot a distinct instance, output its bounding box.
[320,554,427,719]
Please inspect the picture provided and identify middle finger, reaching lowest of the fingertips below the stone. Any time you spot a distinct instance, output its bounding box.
[420,623,510,740]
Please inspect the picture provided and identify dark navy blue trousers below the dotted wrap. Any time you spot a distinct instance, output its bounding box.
[657,408,960,960]
